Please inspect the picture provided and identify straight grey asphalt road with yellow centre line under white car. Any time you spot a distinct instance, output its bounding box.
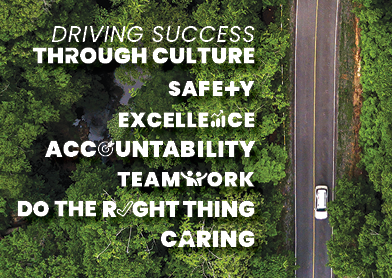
[294,0,338,278]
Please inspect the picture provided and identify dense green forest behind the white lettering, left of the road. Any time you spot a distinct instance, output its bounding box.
[0,0,294,278]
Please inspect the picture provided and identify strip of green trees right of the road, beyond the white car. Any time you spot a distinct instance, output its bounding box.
[328,0,392,277]
